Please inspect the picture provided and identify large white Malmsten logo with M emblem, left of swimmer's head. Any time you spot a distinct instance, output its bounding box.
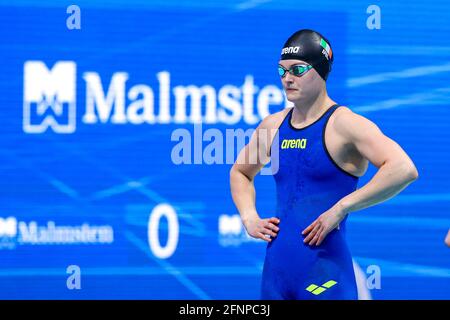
[23,61,289,133]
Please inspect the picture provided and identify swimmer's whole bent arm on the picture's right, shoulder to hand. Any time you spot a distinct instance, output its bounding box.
[302,110,419,245]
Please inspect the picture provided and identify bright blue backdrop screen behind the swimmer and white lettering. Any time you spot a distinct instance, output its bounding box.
[0,0,450,299]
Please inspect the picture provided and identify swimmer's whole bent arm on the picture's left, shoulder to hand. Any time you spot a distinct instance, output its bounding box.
[230,117,279,242]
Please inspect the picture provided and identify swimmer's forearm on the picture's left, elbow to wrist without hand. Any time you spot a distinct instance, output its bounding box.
[230,168,259,225]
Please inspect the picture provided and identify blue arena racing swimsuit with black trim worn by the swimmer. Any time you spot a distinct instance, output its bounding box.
[261,105,358,300]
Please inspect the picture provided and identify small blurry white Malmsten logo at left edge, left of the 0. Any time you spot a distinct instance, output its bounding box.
[0,217,114,249]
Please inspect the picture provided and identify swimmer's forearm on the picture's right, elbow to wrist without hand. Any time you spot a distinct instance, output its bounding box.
[338,161,418,214]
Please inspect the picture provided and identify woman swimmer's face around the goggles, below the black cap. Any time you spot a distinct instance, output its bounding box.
[278,59,325,102]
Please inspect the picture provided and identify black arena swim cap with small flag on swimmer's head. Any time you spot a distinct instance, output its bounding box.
[280,29,333,81]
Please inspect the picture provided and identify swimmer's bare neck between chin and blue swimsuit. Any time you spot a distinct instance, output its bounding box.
[292,88,336,125]
